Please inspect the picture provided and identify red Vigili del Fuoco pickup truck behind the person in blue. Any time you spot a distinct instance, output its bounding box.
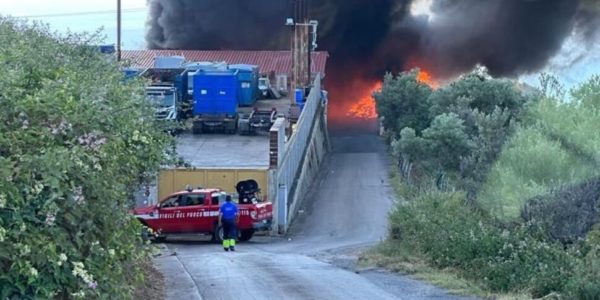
[132,179,273,242]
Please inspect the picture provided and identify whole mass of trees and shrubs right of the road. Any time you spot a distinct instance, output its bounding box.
[363,70,600,299]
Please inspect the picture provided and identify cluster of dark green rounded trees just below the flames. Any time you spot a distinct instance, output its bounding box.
[386,71,539,192]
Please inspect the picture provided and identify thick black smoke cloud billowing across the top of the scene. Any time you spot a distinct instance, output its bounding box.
[146,0,600,78]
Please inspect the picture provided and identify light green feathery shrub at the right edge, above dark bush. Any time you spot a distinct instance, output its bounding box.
[478,76,600,220]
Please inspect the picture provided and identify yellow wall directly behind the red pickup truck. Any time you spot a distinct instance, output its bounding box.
[158,168,269,201]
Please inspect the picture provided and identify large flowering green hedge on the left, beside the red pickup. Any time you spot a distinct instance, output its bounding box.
[0,17,171,299]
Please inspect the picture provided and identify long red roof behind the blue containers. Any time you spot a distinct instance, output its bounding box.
[122,50,329,75]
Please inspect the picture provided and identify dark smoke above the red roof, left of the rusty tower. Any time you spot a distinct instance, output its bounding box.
[146,0,289,50]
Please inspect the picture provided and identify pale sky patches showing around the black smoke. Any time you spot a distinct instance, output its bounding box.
[0,0,600,88]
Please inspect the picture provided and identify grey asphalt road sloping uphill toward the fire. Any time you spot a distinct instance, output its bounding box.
[157,128,476,300]
